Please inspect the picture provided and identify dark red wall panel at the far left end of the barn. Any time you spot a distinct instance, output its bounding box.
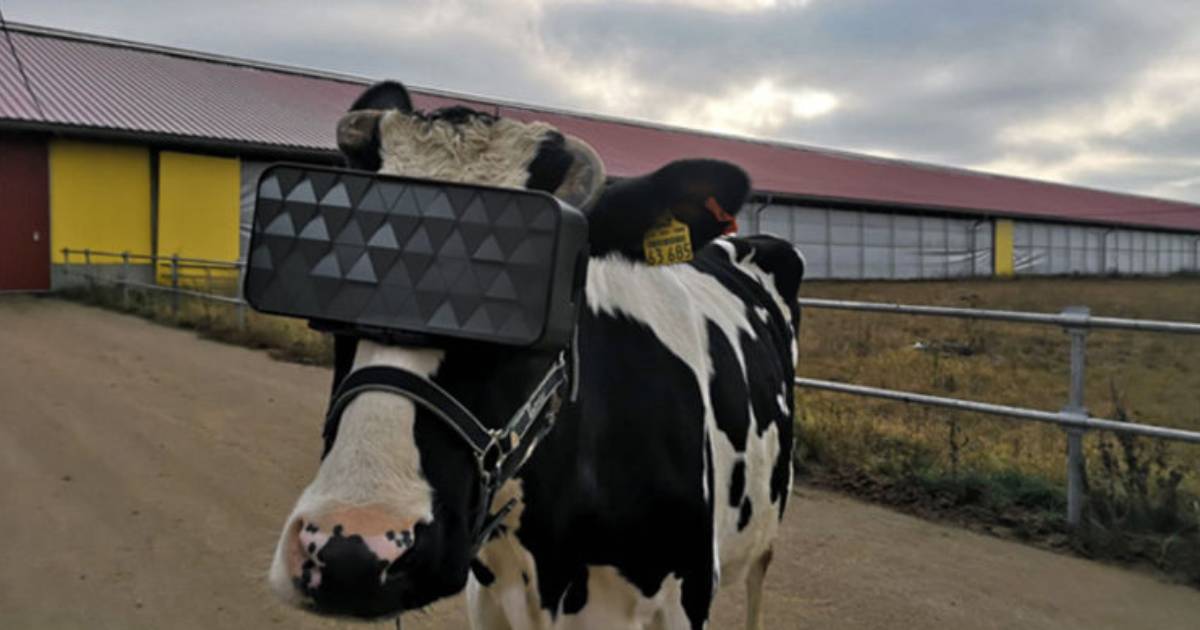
[0,137,50,290]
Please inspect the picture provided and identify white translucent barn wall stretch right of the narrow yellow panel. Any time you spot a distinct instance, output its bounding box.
[1013,221,1200,275]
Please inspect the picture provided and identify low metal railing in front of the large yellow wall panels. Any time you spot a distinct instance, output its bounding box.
[59,247,248,330]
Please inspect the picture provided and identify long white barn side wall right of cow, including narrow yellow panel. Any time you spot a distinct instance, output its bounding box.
[743,203,1200,280]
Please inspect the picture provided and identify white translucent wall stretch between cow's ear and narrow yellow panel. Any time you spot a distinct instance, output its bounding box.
[758,204,992,280]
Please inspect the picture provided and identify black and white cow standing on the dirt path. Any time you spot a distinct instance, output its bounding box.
[270,83,804,630]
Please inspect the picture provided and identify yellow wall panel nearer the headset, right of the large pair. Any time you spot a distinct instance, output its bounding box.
[158,151,241,262]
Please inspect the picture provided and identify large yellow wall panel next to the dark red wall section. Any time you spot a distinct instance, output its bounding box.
[50,139,150,264]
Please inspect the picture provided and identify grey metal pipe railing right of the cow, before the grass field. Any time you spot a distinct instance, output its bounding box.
[796,298,1200,527]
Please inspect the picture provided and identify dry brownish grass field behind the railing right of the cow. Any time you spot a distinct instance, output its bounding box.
[798,277,1200,493]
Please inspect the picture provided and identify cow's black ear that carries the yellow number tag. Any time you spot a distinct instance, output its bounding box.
[588,160,750,259]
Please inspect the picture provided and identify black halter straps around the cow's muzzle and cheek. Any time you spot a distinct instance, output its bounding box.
[322,340,574,557]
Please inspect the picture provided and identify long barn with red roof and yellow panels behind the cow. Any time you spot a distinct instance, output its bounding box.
[0,20,1200,290]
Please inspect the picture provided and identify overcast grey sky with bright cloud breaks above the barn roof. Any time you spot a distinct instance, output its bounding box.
[9,0,1200,202]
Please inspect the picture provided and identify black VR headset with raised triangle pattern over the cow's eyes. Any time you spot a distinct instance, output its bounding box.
[245,164,588,348]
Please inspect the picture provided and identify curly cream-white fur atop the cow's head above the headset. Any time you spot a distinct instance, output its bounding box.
[379,110,554,188]
